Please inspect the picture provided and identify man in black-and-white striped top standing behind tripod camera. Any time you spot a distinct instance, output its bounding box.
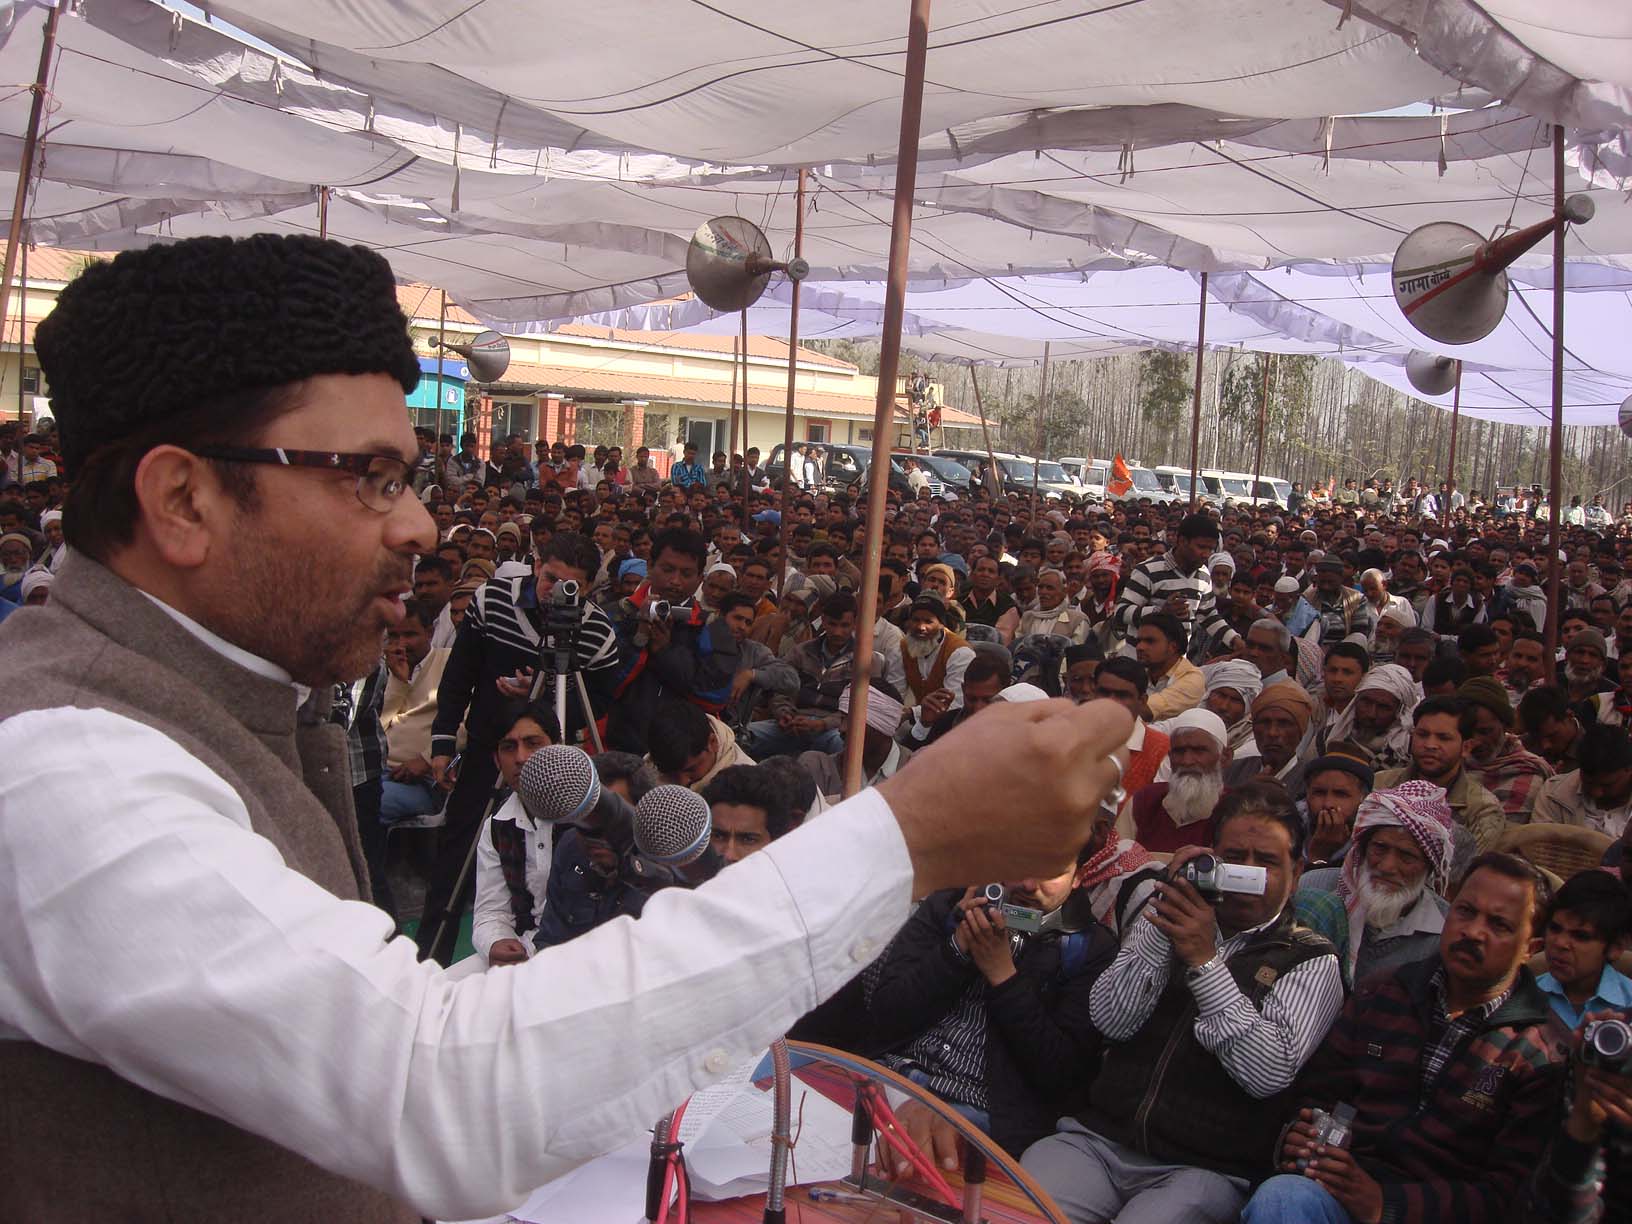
[418,532,617,965]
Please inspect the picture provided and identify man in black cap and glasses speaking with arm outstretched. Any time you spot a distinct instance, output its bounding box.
[0,235,1129,1224]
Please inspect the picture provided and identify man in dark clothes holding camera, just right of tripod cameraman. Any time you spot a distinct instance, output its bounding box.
[607,527,741,756]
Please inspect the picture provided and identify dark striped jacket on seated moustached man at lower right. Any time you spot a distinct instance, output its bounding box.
[1296,956,1567,1224]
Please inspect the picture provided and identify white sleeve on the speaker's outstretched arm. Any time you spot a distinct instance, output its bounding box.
[0,708,912,1217]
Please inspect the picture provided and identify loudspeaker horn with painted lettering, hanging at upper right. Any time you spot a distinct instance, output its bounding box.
[1390,196,1593,344]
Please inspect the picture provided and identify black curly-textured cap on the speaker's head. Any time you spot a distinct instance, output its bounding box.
[34,233,419,467]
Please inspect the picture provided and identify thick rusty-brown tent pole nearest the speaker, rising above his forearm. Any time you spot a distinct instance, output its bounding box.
[844,0,929,806]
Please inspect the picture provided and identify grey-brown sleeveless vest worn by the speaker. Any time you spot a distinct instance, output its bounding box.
[0,555,418,1224]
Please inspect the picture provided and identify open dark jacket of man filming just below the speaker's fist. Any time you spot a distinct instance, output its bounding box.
[867,889,1116,1155]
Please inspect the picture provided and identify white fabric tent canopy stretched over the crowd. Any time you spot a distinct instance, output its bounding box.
[0,0,1632,424]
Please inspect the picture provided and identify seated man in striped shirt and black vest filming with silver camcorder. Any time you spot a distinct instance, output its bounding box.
[1023,782,1343,1224]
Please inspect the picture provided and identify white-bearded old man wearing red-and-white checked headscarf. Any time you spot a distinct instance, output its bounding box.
[1296,780,1452,984]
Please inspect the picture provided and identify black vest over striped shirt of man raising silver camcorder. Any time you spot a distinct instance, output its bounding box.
[1080,904,1335,1182]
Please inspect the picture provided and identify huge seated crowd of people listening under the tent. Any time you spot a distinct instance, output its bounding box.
[0,428,1632,1224]
